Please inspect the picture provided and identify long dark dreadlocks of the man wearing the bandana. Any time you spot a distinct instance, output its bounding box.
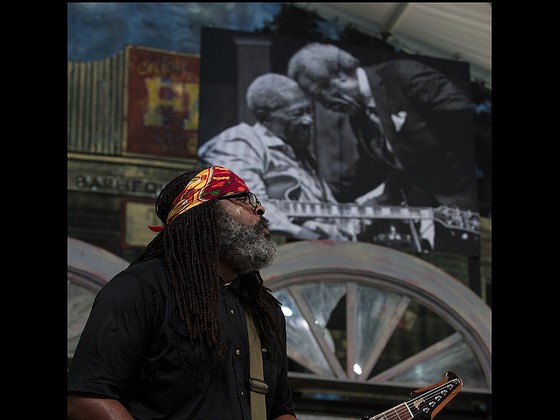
[132,164,285,360]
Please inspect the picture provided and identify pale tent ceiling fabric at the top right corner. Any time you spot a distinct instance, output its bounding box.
[293,3,492,88]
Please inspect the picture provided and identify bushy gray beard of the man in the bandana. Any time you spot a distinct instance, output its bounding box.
[216,208,278,273]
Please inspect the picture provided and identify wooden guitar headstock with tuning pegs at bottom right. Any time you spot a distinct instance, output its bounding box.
[406,371,463,419]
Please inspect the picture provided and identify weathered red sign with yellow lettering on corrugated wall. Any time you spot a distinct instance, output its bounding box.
[125,46,200,158]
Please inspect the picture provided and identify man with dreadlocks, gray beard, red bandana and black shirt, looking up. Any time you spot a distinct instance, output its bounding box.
[68,166,296,420]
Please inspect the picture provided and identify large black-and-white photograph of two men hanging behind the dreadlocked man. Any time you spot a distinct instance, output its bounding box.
[197,28,480,256]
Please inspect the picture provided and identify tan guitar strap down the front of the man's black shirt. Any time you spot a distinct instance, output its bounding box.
[245,308,268,420]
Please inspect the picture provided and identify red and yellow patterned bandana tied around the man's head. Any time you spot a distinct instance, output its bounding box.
[148,166,249,232]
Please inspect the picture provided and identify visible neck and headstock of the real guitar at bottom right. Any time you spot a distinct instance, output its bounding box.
[361,371,463,420]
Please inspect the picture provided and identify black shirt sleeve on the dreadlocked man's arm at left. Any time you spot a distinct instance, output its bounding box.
[68,272,157,399]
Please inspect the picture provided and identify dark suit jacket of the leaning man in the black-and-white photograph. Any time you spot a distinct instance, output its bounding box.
[349,59,478,211]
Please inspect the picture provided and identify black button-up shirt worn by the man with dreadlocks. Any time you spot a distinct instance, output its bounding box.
[68,259,293,420]
